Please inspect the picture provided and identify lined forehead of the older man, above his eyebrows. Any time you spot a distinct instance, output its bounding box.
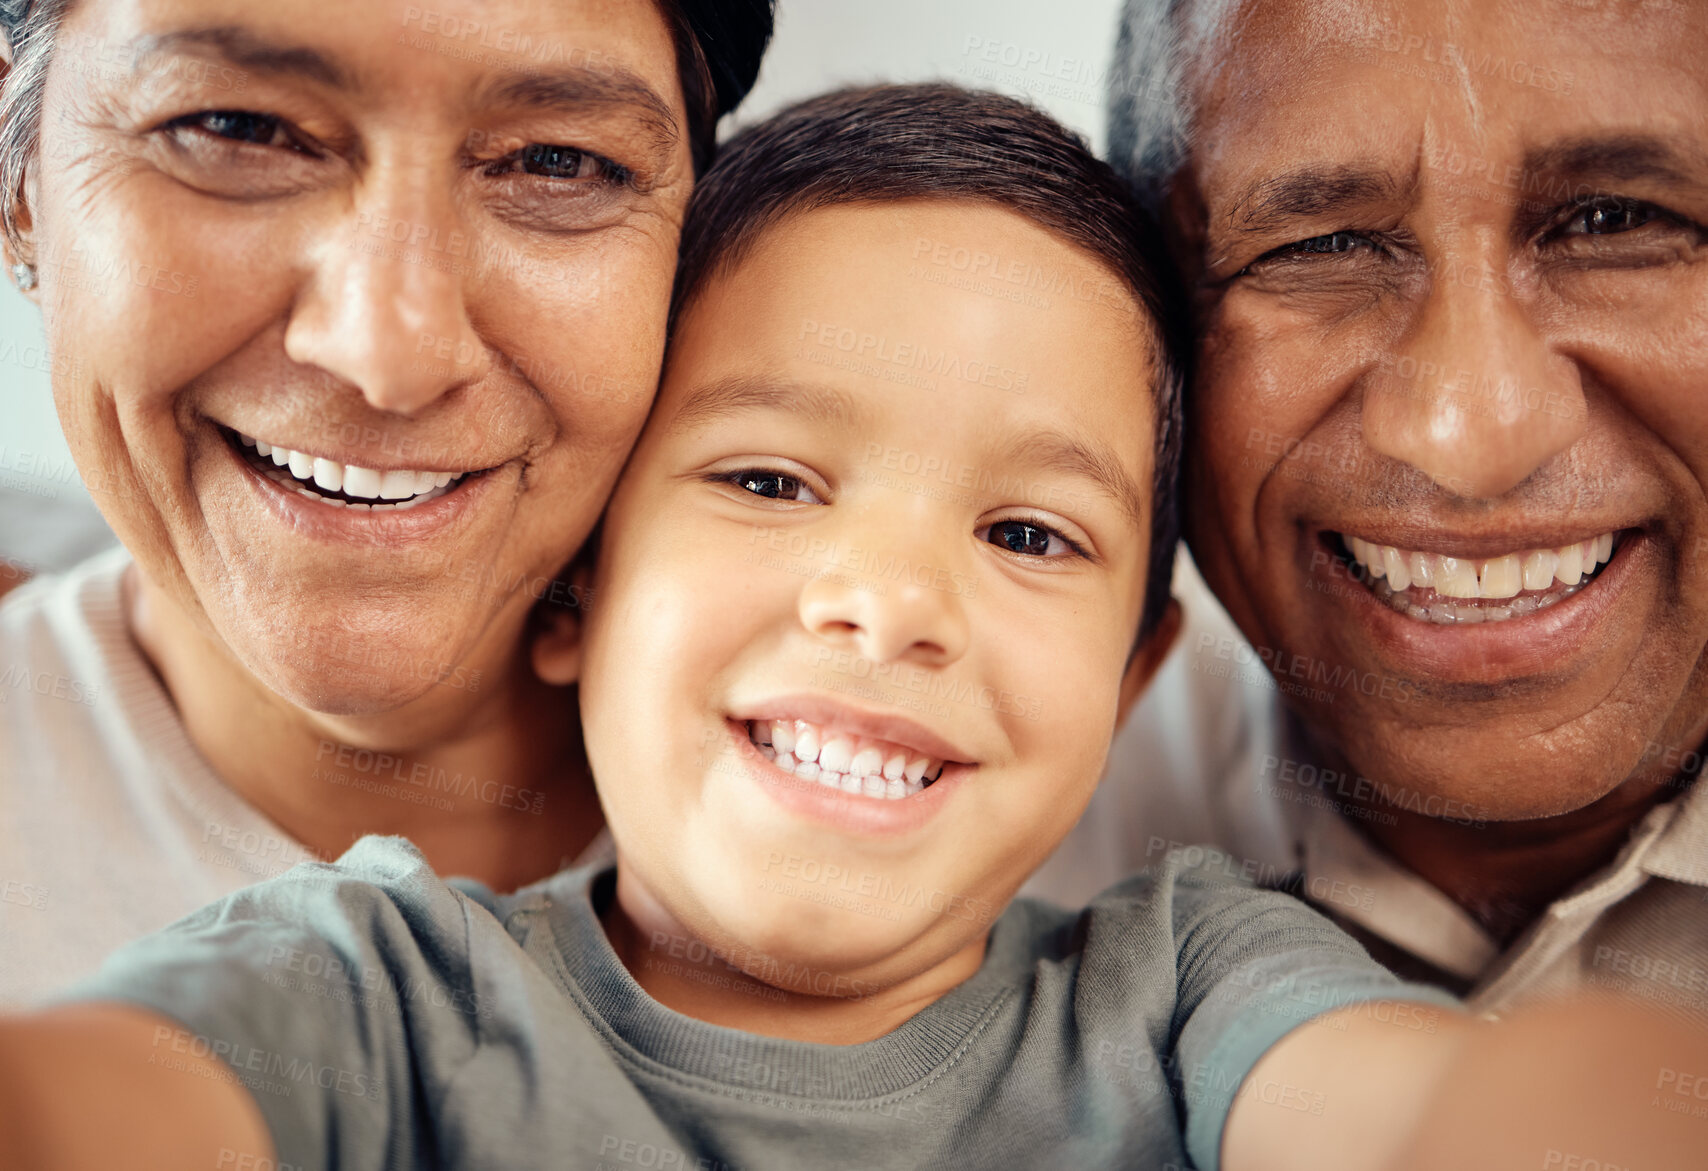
[1192,0,1708,199]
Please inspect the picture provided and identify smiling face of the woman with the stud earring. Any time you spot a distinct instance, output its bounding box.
[27,0,692,714]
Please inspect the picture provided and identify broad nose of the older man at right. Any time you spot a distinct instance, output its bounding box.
[1363,266,1585,500]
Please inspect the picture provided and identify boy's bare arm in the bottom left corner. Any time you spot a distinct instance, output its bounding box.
[0,1004,273,1171]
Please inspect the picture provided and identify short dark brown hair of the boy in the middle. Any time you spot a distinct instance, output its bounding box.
[670,84,1185,642]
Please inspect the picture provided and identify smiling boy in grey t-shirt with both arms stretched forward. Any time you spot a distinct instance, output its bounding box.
[0,87,1703,1171]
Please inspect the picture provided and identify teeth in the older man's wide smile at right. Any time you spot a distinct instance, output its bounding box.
[1341,533,1616,625]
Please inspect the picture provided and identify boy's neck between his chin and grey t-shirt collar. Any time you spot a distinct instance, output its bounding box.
[601,862,989,1045]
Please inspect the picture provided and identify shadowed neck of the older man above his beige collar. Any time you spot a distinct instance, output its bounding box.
[1312,729,1708,947]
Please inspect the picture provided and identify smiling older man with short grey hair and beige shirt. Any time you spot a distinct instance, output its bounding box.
[1110,0,1708,1019]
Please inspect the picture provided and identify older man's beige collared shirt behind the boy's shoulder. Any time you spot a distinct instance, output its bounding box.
[1025,558,1708,1019]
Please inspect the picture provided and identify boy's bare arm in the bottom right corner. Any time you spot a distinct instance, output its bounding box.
[1221,1000,1708,1171]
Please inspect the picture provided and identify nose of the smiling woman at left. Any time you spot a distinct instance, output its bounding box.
[285,164,492,415]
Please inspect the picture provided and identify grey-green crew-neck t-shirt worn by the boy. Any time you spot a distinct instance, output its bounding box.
[72,838,1454,1171]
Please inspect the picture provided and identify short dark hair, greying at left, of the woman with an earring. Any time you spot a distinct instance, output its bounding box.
[0,0,775,254]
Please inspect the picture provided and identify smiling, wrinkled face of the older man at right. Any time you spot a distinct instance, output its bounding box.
[1179,0,1708,819]
